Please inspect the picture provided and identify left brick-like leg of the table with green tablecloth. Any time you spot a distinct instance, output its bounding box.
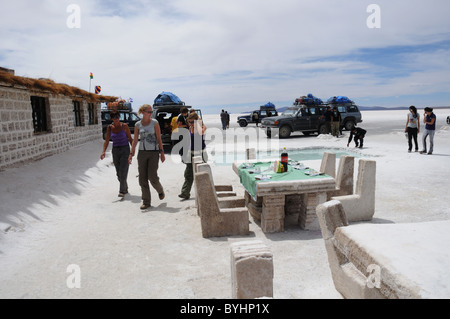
[261,195,285,233]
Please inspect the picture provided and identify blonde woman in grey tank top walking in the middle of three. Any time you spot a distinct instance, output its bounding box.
[130,104,166,209]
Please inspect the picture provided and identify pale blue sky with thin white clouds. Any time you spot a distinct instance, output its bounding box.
[0,0,450,114]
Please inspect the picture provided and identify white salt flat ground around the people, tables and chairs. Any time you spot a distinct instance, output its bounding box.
[0,109,450,299]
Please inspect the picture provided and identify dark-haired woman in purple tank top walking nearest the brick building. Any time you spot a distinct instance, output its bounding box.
[100,112,133,197]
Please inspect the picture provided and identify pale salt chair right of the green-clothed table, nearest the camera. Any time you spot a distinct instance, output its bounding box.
[331,159,376,222]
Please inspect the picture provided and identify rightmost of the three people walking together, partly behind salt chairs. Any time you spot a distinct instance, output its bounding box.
[178,113,208,199]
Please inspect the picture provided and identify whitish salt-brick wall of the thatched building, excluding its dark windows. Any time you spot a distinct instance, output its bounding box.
[0,83,102,171]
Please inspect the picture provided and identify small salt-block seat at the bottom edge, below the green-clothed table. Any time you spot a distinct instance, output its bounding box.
[231,240,274,299]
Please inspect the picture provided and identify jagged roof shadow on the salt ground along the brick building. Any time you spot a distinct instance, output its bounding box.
[0,141,102,238]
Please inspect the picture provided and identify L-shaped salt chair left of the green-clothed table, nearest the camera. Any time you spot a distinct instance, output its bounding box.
[194,172,249,238]
